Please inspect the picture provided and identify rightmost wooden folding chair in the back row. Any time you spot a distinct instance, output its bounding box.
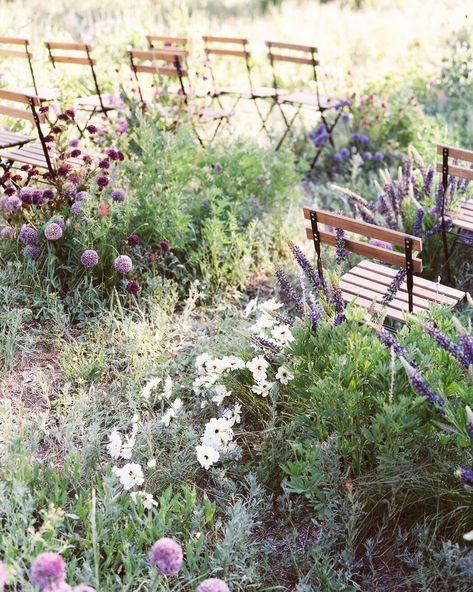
[266,41,341,161]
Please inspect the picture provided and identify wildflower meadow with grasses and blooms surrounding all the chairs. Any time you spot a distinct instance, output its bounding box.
[0,0,473,592]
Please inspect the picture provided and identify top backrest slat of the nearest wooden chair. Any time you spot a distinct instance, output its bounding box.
[304,208,422,252]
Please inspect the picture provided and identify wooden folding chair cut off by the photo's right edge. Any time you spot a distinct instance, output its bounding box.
[437,144,473,281]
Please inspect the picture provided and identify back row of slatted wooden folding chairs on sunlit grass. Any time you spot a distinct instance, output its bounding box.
[0,35,341,157]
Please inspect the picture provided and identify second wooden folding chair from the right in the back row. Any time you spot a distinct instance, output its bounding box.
[202,35,288,139]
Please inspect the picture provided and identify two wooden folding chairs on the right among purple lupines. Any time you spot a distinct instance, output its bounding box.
[304,145,473,322]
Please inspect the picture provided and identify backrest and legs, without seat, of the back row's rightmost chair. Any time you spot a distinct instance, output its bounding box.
[265,41,341,163]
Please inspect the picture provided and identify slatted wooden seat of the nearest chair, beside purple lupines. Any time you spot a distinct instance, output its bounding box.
[340,260,465,321]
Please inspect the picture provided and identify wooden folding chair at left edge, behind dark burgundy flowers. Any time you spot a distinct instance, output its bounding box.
[0,89,83,177]
